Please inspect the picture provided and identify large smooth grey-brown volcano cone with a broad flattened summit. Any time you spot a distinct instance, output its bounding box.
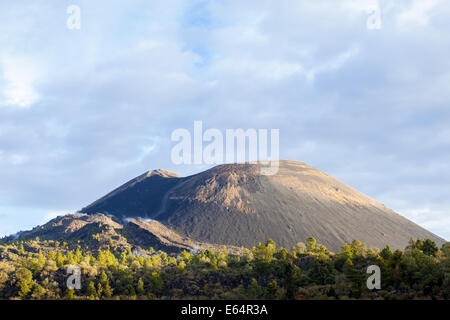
[81,160,445,251]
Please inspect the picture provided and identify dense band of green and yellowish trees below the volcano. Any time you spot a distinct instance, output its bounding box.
[0,235,450,300]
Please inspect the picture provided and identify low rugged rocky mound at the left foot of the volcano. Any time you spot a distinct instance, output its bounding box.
[12,214,245,255]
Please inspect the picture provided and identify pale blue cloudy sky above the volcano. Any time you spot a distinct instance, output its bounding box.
[0,0,450,240]
